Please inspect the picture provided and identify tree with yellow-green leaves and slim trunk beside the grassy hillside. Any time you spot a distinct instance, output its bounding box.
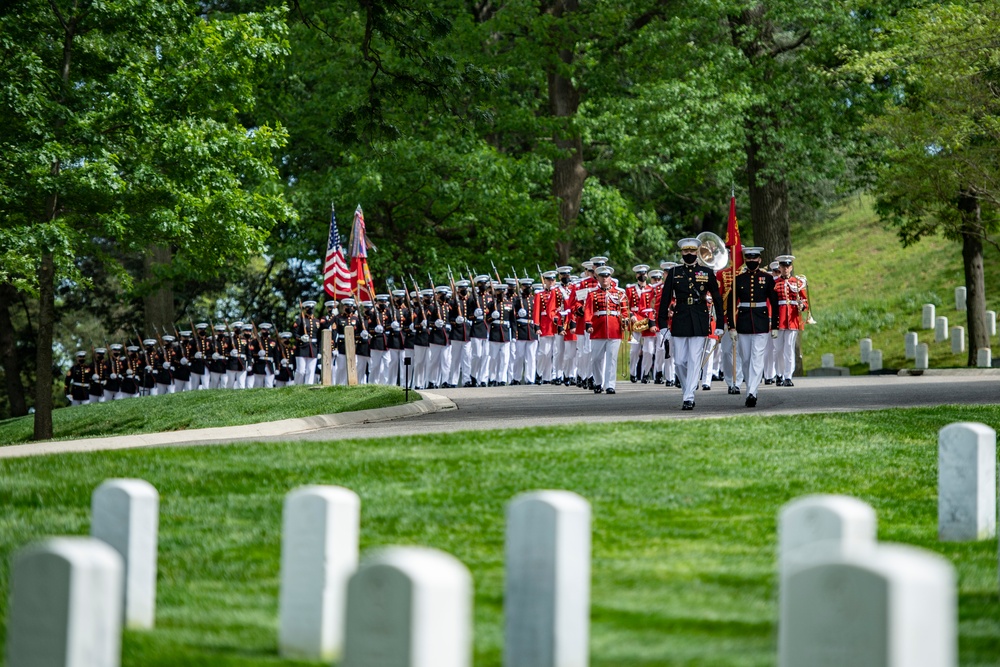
[844,0,1000,366]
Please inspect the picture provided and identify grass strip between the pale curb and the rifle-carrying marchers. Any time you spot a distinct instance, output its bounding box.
[0,385,410,445]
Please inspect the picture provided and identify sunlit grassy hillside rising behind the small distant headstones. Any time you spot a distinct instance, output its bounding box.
[792,199,1000,372]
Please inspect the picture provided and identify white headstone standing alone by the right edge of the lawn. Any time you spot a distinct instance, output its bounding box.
[938,422,997,542]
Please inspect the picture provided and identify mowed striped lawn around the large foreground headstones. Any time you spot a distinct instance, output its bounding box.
[0,407,1000,667]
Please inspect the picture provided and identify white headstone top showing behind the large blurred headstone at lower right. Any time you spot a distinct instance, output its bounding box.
[778,495,878,572]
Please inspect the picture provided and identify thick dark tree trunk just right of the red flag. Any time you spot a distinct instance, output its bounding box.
[747,124,792,265]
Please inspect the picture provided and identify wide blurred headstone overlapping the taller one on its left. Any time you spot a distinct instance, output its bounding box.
[342,547,472,667]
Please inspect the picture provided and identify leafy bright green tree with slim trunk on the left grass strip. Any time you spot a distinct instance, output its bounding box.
[0,0,292,439]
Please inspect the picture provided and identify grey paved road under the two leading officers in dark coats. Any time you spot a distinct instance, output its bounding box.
[189,375,1000,444]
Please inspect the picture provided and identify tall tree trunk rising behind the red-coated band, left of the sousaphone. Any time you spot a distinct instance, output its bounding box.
[548,0,587,264]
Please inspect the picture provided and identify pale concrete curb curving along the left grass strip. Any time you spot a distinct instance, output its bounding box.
[0,391,458,459]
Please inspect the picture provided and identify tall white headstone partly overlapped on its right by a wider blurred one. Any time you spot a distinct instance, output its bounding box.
[278,486,361,662]
